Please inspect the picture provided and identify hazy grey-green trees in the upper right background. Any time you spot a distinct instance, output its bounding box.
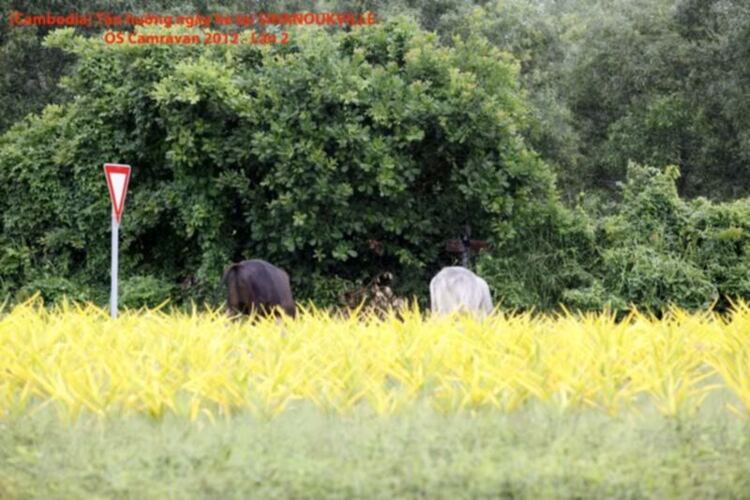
[428,0,750,199]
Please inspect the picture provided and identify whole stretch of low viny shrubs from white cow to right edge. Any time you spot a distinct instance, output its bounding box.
[479,164,750,311]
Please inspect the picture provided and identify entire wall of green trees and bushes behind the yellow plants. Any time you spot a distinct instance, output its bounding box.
[0,0,750,309]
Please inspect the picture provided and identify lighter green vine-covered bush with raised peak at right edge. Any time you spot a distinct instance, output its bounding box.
[595,164,750,310]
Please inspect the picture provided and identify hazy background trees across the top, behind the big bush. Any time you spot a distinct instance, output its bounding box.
[0,0,750,199]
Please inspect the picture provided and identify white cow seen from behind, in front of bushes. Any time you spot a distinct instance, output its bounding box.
[430,267,492,316]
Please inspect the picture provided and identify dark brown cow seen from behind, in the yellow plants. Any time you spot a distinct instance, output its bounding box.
[222,259,297,317]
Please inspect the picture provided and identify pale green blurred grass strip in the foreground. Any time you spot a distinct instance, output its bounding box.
[0,405,750,499]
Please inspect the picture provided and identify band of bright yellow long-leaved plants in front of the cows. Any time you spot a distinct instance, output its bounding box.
[0,300,750,420]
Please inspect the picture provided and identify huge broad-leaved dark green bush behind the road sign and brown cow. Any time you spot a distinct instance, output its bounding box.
[0,20,553,304]
